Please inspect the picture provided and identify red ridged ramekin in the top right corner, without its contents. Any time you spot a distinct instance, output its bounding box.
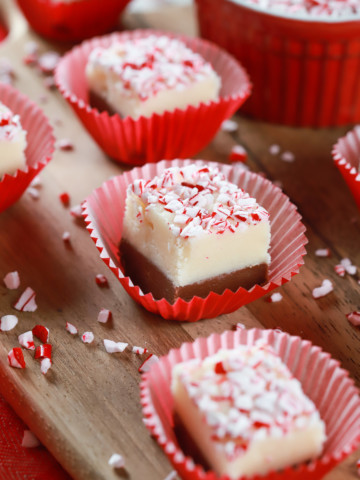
[196,0,360,127]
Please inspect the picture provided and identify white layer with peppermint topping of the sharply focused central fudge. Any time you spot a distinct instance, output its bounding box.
[123,164,270,286]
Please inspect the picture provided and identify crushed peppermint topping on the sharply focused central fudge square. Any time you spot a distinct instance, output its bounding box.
[128,164,269,239]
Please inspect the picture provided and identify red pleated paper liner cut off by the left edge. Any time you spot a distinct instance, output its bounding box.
[0,83,55,212]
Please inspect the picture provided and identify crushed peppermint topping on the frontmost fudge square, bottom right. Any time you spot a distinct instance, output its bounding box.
[174,344,319,460]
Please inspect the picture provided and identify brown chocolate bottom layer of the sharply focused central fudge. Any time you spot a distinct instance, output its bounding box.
[120,240,268,303]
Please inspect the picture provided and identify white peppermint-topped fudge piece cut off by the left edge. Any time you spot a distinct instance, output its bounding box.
[0,103,27,178]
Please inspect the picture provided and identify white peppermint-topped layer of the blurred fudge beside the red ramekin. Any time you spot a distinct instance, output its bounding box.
[86,35,220,118]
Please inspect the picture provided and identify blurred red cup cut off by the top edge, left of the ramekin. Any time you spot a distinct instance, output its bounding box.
[17,0,130,42]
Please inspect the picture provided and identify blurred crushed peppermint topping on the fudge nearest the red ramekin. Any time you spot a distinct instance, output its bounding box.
[87,35,217,101]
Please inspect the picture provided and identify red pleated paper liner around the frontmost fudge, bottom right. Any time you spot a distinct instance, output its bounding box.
[140,329,360,480]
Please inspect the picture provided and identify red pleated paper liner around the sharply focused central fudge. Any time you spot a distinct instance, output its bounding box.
[83,160,307,322]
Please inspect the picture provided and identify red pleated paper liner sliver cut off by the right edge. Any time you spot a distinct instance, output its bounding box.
[332,126,360,209]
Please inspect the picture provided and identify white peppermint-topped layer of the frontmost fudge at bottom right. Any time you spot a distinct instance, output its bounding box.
[172,344,326,479]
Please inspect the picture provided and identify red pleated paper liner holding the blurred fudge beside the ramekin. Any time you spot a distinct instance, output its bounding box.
[55,30,251,165]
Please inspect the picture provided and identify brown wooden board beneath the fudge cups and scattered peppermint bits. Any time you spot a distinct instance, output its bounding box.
[0,0,360,480]
